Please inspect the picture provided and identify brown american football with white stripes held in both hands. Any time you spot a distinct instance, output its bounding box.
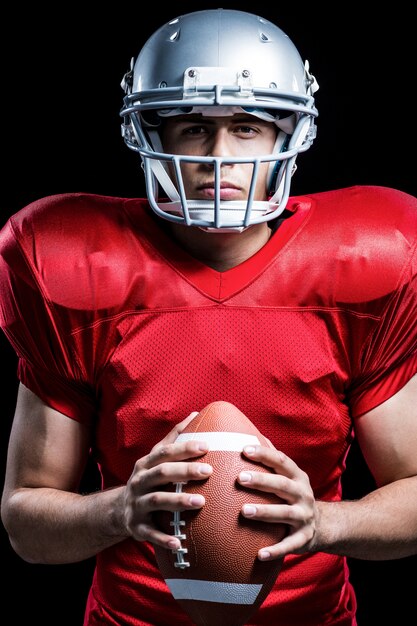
[155,401,287,626]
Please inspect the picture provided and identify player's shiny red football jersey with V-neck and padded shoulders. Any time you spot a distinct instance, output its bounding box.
[0,187,417,626]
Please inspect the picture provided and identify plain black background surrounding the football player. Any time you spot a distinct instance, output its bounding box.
[0,2,417,626]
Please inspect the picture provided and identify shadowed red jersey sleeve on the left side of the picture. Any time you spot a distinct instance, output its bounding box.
[0,218,95,422]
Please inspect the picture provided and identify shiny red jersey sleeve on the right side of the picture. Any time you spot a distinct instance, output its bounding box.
[349,241,417,417]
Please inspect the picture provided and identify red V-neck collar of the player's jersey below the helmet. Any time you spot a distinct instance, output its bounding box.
[122,197,311,302]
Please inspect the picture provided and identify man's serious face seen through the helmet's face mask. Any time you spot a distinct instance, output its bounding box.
[162,113,277,200]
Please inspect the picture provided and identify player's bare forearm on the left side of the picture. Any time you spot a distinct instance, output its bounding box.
[2,487,128,564]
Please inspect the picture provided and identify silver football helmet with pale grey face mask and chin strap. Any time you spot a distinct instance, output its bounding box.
[120,9,318,231]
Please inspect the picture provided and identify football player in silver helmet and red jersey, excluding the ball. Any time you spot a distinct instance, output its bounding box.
[0,9,417,626]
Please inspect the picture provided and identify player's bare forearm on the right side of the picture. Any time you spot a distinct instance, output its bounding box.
[314,477,417,560]
